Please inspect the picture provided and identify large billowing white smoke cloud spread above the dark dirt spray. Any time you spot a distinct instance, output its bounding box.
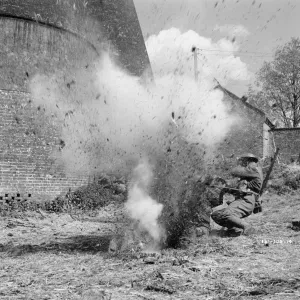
[30,54,237,174]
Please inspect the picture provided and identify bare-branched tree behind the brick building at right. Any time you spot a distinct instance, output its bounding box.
[248,38,300,128]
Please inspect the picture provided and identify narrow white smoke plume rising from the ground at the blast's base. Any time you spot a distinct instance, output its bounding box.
[125,160,163,247]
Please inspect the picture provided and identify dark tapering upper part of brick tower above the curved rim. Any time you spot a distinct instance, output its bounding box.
[0,0,150,76]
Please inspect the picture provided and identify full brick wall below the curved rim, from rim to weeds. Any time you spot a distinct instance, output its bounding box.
[0,18,98,200]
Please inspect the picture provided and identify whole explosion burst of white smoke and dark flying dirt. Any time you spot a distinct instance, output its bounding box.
[30,30,248,246]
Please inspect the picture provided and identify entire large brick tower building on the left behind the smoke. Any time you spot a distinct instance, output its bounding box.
[0,0,150,200]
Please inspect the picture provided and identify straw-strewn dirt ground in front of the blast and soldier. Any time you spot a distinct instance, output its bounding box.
[0,194,300,300]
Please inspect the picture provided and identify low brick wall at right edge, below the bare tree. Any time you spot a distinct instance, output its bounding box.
[271,128,300,164]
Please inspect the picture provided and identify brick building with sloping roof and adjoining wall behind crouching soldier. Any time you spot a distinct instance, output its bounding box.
[216,84,300,169]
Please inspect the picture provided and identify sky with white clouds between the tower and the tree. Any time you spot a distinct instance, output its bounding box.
[134,0,300,97]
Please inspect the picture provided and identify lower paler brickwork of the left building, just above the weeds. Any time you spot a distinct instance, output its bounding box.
[0,90,89,200]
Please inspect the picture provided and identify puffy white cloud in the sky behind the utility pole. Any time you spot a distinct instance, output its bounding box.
[146,28,250,84]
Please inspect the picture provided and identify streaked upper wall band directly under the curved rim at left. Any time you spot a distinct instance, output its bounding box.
[0,17,98,90]
